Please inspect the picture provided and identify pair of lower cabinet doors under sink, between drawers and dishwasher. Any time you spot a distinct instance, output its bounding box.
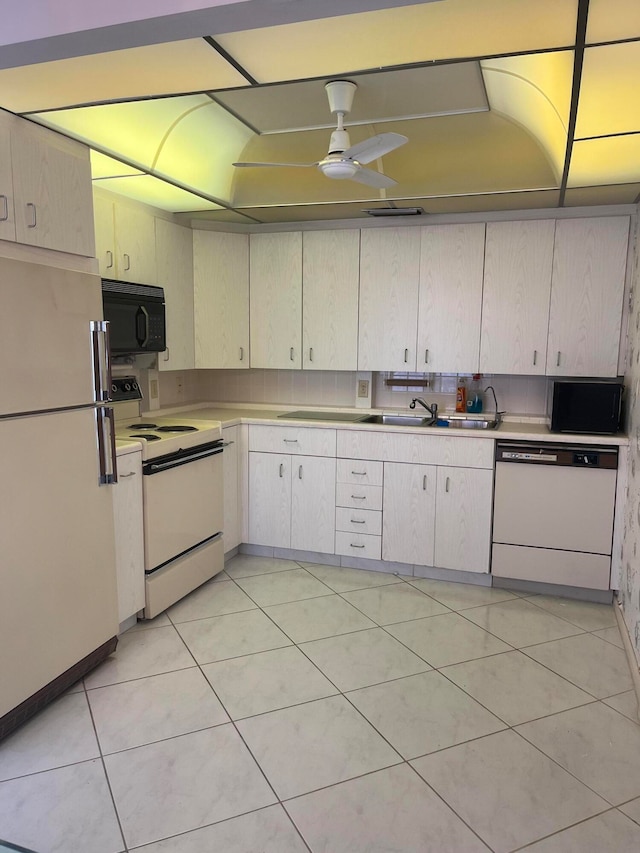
[382,462,493,572]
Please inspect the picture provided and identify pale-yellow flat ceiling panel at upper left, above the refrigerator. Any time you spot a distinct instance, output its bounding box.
[0,39,247,113]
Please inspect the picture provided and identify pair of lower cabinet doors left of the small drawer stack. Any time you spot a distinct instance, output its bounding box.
[249,451,336,554]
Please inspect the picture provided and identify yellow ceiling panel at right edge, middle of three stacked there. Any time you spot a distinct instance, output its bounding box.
[575,43,640,139]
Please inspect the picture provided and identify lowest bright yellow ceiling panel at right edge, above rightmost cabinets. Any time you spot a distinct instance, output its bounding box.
[568,133,640,187]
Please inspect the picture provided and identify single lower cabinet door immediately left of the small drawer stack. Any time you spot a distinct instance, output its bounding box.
[291,456,336,554]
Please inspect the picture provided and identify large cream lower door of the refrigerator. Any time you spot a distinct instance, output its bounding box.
[0,409,118,717]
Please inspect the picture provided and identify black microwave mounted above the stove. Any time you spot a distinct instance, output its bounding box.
[102,278,167,355]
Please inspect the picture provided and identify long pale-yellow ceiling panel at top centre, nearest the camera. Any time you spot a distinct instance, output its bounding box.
[215,0,577,83]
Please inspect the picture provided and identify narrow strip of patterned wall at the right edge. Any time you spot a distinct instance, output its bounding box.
[619,206,640,665]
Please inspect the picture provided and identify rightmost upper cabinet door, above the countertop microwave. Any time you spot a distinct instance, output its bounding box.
[547,216,629,376]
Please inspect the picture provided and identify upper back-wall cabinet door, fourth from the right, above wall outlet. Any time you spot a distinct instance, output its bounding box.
[358,228,420,371]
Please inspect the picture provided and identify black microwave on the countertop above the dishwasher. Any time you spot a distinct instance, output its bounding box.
[551,379,623,435]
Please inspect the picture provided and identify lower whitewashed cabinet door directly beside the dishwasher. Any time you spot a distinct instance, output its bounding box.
[434,468,493,572]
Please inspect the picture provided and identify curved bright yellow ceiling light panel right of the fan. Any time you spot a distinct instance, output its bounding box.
[481,51,573,182]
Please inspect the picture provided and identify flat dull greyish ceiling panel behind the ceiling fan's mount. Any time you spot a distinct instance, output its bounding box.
[215,62,488,133]
